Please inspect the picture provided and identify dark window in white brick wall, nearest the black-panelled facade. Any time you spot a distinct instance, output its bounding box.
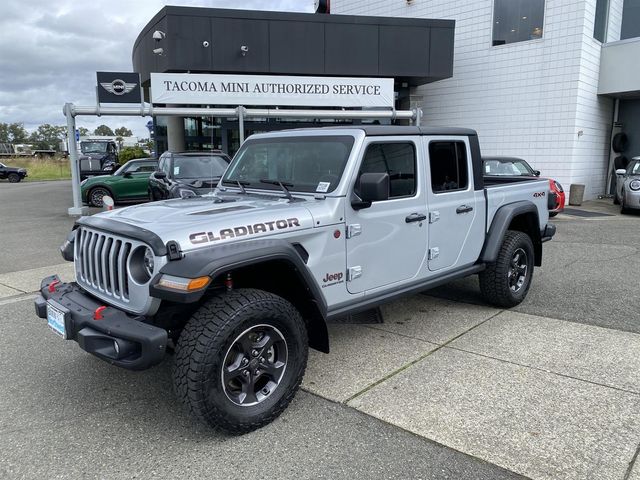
[493,0,544,46]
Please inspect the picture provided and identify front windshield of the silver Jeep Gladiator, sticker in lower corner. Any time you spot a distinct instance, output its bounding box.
[222,136,354,193]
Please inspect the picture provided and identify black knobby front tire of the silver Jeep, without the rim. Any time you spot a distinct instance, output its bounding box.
[173,289,308,434]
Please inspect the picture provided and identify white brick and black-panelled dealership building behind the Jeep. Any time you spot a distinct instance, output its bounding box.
[133,0,640,198]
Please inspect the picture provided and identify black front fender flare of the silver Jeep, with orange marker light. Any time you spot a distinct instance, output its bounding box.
[149,239,329,353]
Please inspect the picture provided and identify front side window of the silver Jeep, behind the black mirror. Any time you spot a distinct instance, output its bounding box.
[355,143,416,198]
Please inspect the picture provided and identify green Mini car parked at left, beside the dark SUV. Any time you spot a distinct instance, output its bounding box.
[80,158,158,207]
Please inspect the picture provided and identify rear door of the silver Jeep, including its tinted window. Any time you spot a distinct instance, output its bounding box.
[424,137,485,271]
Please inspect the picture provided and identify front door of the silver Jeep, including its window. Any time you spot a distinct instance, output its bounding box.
[346,136,427,293]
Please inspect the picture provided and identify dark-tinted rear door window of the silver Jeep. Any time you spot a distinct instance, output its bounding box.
[429,141,469,193]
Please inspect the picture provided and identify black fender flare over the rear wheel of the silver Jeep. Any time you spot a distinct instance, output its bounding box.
[480,200,542,266]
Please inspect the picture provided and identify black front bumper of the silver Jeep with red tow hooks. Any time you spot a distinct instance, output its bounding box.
[35,275,167,370]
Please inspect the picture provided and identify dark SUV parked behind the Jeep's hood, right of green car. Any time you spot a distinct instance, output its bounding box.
[149,150,231,200]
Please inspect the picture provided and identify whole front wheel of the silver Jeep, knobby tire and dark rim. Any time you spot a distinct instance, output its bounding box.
[173,289,308,434]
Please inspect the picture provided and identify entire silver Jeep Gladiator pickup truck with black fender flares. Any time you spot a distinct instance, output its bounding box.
[35,126,555,433]
